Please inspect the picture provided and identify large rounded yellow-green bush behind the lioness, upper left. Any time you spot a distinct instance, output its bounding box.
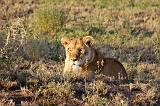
[32,2,67,35]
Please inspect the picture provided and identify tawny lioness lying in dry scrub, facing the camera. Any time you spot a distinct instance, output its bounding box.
[61,36,127,79]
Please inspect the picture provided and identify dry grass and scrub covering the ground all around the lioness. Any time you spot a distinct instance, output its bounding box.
[0,0,160,106]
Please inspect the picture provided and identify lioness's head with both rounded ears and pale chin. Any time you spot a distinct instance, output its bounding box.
[61,36,94,66]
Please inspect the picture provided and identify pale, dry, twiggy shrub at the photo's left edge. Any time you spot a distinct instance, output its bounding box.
[0,19,28,68]
